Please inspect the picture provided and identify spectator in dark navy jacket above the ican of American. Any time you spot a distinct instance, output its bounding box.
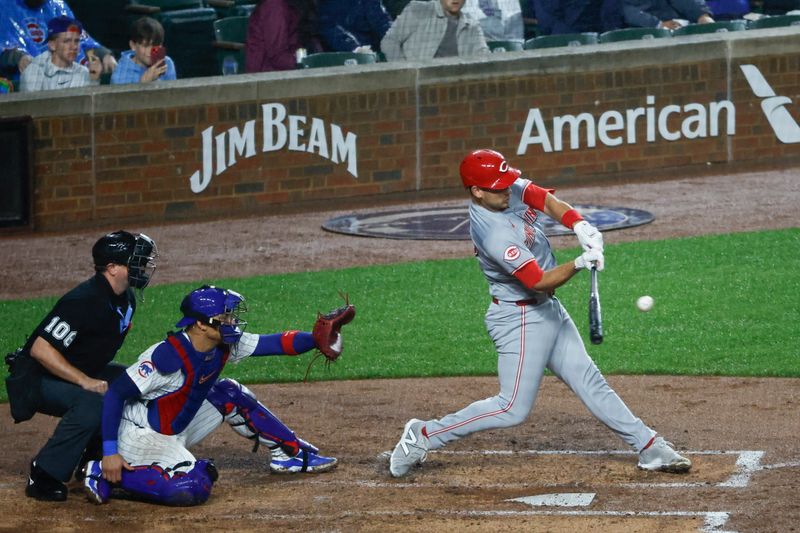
[623,0,714,30]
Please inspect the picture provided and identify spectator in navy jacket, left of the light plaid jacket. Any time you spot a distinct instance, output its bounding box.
[318,0,392,52]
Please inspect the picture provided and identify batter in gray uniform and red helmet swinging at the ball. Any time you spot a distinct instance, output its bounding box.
[389,150,691,477]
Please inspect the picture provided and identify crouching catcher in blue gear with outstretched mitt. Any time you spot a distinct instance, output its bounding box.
[84,285,355,506]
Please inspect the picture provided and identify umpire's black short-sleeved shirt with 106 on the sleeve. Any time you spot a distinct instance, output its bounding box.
[25,273,136,378]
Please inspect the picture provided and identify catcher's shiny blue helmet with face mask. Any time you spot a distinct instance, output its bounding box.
[175,285,247,344]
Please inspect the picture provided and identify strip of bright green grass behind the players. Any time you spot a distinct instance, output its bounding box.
[0,228,800,399]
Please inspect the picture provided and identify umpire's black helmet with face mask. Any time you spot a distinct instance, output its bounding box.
[92,230,158,296]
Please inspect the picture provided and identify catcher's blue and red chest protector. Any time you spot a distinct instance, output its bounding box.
[147,334,230,435]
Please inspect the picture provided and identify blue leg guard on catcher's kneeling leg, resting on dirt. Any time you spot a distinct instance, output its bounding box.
[120,460,217,507]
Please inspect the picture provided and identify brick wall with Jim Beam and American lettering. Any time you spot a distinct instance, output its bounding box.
[0,29,800,230]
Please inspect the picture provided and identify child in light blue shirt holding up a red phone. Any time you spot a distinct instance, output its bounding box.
[111,17,178,84]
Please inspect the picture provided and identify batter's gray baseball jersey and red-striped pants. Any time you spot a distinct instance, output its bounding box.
[425,178,655,451]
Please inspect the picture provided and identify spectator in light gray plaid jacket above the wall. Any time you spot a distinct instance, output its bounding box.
[381,0,489,61]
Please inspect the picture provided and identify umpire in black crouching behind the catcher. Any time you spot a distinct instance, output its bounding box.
[6,231,158,501]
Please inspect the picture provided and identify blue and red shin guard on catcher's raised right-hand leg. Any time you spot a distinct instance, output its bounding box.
[208,379,319,457]
